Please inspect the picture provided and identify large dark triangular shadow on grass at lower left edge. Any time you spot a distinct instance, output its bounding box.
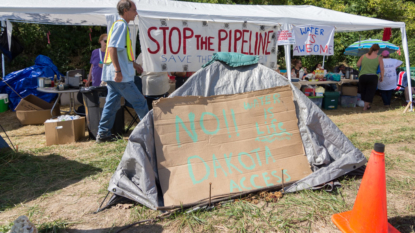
[0,151,102,211]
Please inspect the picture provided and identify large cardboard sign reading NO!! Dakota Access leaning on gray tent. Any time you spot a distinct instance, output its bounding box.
[153,86,311,206]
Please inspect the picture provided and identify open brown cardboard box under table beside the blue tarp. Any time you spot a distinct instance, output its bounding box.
[15,95,61,125]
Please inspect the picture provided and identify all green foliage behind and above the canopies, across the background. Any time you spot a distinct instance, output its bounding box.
[2,0,415,73]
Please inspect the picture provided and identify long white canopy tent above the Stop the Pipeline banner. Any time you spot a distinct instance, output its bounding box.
[135,0,412,107]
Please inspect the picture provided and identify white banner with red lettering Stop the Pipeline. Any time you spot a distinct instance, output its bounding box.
[139,17,277,72]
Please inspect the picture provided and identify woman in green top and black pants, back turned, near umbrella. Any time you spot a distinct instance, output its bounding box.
[357,44,384,111]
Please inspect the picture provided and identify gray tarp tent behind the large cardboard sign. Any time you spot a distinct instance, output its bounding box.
[108,62,367,209]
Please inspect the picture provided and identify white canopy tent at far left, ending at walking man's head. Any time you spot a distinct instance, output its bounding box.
[0,0,138,77]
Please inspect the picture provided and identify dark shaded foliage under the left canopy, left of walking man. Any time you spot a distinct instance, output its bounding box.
[2,23,106,73]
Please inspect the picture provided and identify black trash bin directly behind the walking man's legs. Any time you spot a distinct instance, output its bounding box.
[81,86,124,140]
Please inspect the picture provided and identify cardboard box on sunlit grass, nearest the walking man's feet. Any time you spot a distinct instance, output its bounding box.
[45,117,85,146]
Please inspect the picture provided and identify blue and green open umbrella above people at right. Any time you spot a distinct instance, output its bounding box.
[344,39,399,56]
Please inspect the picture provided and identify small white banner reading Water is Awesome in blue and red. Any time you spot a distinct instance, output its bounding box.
[294,25,334,56]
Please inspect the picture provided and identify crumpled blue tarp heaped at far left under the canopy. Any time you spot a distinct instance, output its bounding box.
[0,55,63,110]
